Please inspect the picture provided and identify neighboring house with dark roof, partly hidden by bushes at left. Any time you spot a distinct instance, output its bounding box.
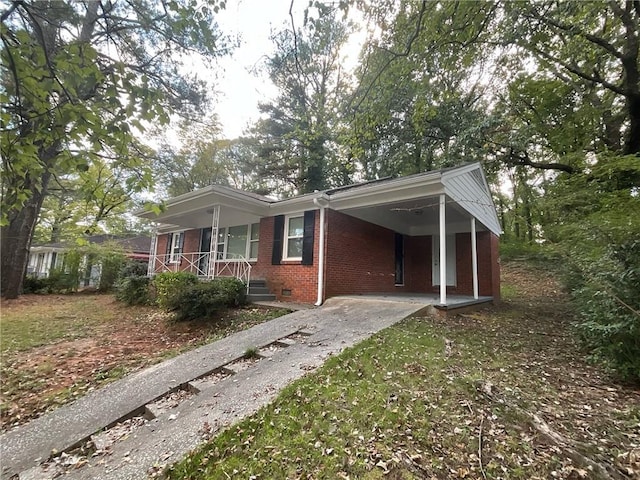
[27,235,151,286]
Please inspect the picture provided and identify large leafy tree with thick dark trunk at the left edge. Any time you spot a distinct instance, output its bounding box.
[0,0,225,298]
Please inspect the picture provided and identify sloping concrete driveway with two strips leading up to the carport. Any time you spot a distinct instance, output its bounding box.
[0,298,424,480]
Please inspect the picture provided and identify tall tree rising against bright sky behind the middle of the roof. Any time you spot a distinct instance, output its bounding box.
[252,7,350,195]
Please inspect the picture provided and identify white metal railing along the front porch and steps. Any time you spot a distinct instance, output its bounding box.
[149,252,251,285]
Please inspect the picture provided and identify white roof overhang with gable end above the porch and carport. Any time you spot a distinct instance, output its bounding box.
[136,163,501,235]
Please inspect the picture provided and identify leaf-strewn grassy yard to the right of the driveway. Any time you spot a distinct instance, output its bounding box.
[167,262,640,479]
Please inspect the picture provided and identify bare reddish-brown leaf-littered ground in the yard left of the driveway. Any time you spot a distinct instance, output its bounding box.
[0,294,284,431]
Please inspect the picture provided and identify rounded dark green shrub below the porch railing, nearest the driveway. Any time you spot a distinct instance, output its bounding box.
[167,278,246,320]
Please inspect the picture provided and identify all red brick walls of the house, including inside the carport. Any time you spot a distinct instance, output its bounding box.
[156,215,500,303]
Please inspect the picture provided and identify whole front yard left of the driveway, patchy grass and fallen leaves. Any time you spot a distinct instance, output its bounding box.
[0,294,287,430]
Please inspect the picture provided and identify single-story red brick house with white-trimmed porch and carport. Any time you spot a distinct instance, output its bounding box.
[136,163,501,305]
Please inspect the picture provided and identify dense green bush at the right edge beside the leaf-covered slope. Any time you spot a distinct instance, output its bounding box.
[546,155,640,381]
